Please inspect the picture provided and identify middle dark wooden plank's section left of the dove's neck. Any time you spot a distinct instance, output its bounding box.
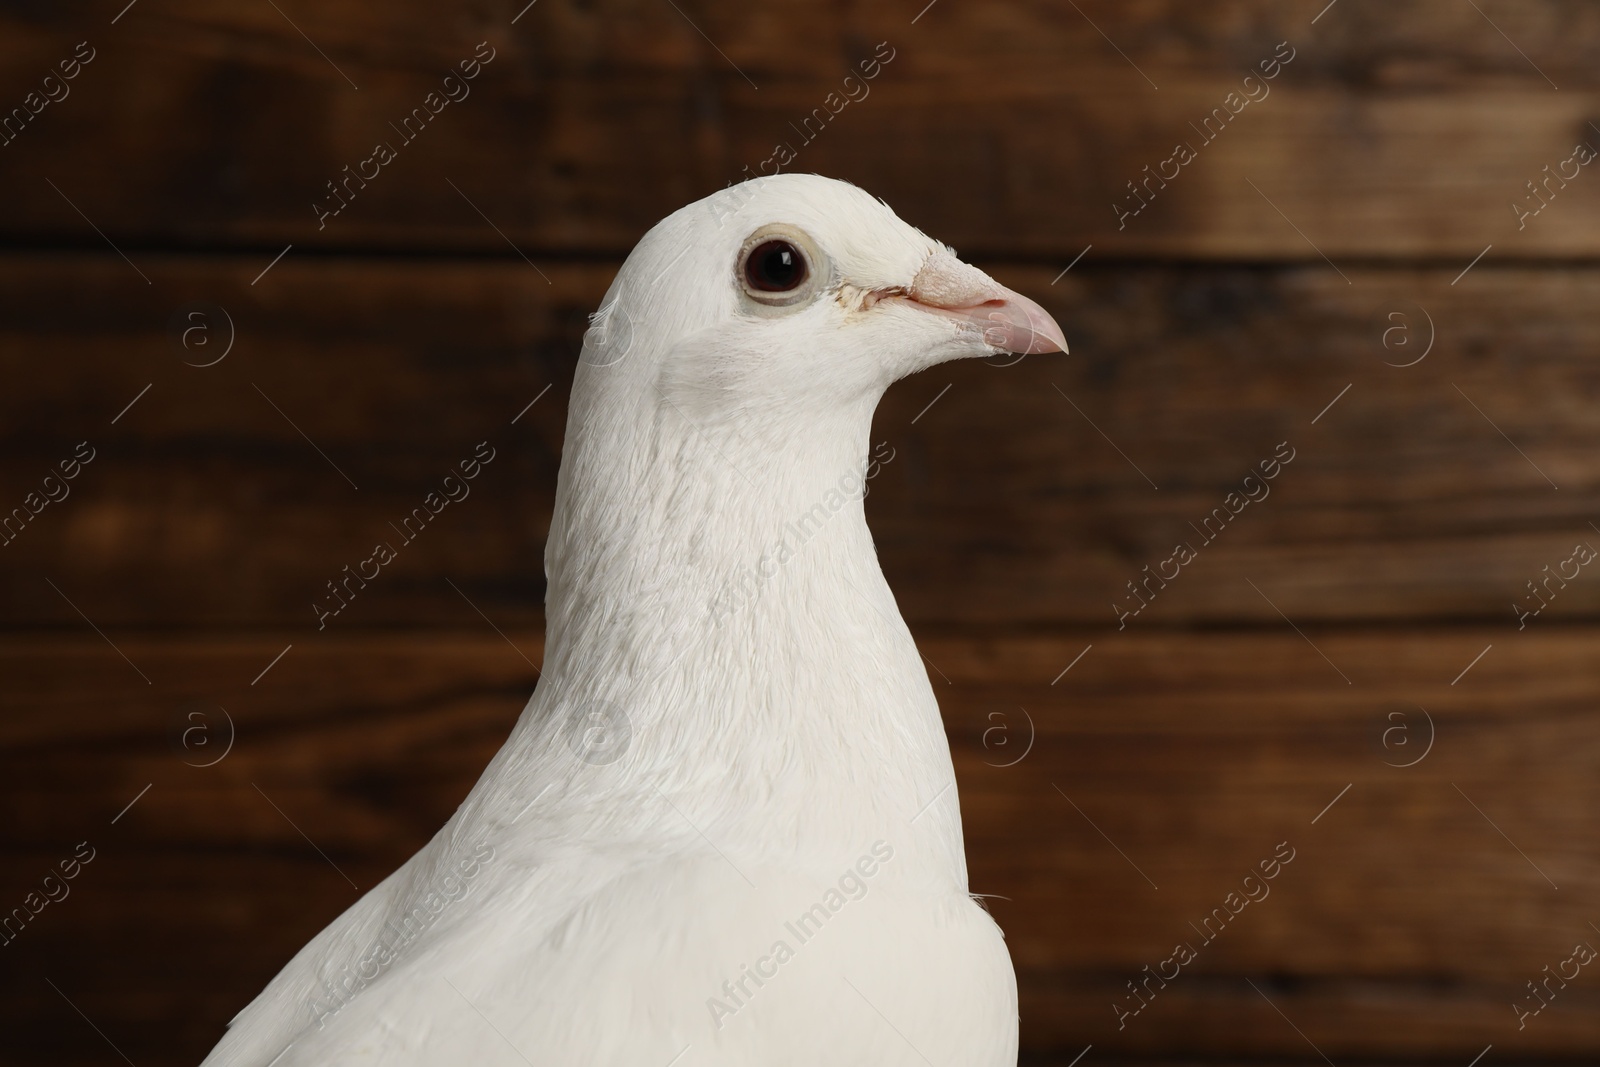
[5,251,582,630]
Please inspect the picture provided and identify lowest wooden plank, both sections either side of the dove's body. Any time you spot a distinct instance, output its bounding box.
[0,627,1600,1064]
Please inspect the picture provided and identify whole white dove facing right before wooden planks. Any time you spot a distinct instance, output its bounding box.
[205,174,1066,1067]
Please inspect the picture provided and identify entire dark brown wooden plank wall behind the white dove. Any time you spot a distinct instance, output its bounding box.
[0,0,1600,1067]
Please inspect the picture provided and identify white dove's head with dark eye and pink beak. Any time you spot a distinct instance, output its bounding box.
[578,174,1067,418]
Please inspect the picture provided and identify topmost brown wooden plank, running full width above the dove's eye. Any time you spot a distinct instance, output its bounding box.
[0,0,1600,255]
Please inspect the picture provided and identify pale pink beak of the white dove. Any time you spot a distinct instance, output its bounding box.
[904,251,1067,355]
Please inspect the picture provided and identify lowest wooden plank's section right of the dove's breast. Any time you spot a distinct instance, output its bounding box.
[923,630,1600,1062]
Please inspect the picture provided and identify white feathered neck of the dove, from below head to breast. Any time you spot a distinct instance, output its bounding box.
[539,397,965,880]
